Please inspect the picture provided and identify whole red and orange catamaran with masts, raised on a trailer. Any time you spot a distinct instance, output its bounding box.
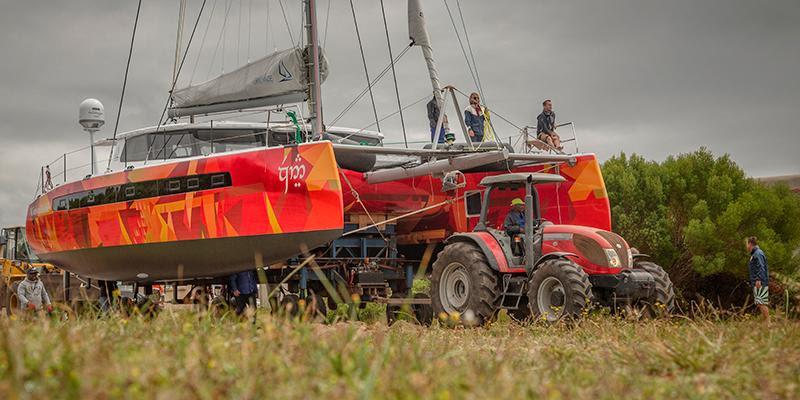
[27,0,611,290]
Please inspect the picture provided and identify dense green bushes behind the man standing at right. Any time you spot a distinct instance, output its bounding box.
[602,148,800,305]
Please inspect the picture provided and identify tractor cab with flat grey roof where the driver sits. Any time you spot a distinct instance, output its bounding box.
[474,173,565,271]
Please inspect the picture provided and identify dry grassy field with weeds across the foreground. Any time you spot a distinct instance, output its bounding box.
[0,311,800,399]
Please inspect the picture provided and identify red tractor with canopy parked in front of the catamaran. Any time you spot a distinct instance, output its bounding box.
[431,173,675,323]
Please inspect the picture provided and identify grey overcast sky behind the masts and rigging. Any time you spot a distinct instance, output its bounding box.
[0,0,800,226]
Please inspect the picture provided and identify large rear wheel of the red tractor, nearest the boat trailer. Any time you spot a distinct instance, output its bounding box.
[431,242,500,325]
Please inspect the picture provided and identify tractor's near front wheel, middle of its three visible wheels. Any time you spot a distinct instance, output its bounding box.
[528,258,593,321]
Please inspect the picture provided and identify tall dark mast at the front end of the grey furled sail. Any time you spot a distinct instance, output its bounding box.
[303,0,323,138]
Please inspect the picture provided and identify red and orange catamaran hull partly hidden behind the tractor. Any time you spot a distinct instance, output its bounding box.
[342,154,611,244]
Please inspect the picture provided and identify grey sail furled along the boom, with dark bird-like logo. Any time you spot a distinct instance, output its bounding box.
[169,48,328,117]
